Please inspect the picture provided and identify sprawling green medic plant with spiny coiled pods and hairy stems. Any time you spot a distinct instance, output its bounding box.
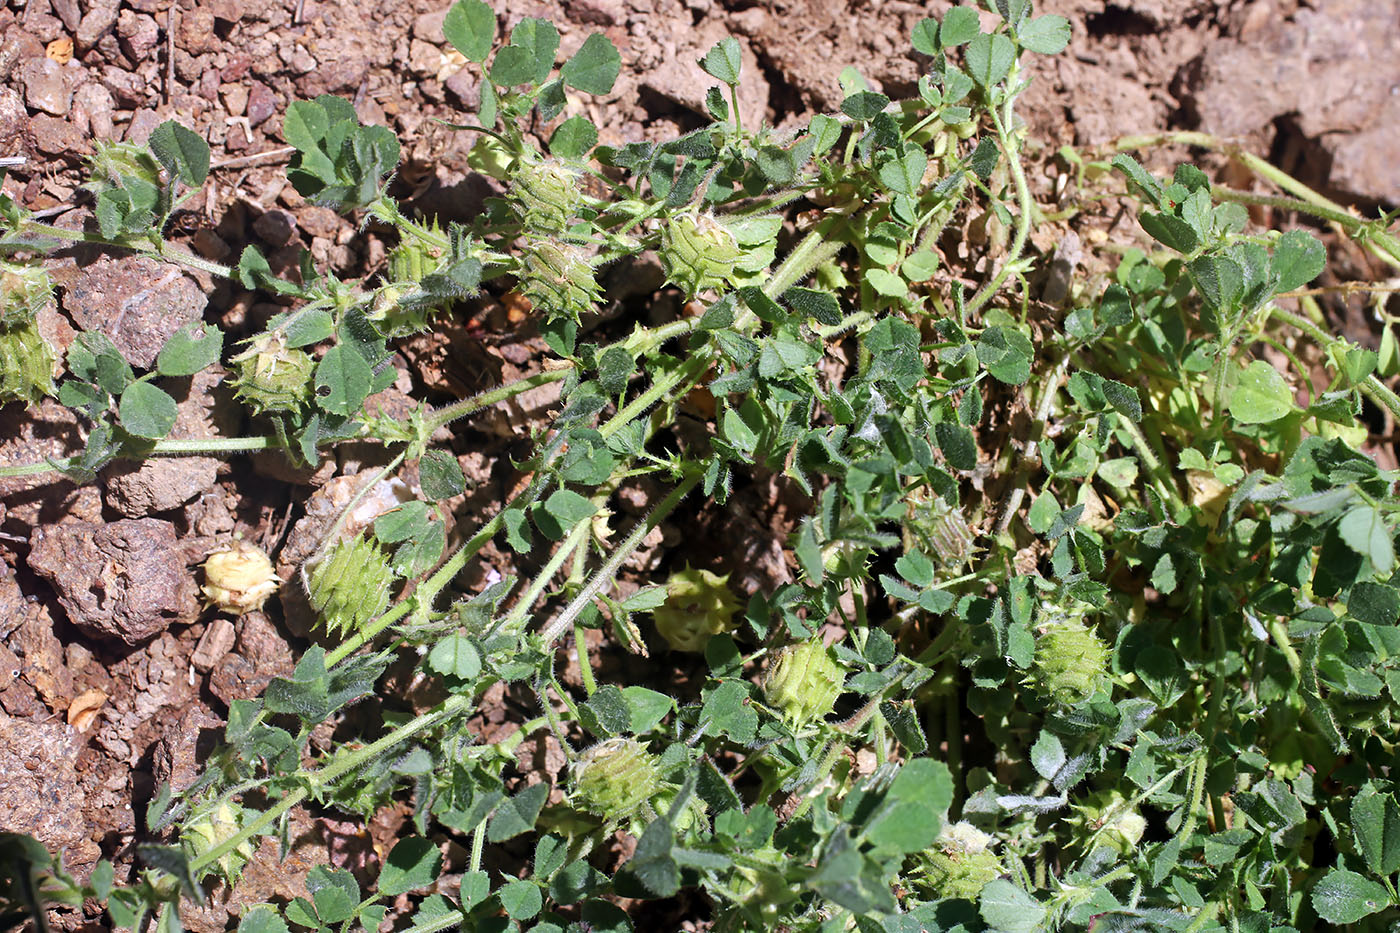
[0,0,1400,933]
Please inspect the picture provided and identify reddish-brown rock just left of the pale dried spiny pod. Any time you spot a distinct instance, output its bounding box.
[28,518,199,644]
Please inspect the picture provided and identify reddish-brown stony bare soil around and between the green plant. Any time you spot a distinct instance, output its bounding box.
[0,0,1400,933]
